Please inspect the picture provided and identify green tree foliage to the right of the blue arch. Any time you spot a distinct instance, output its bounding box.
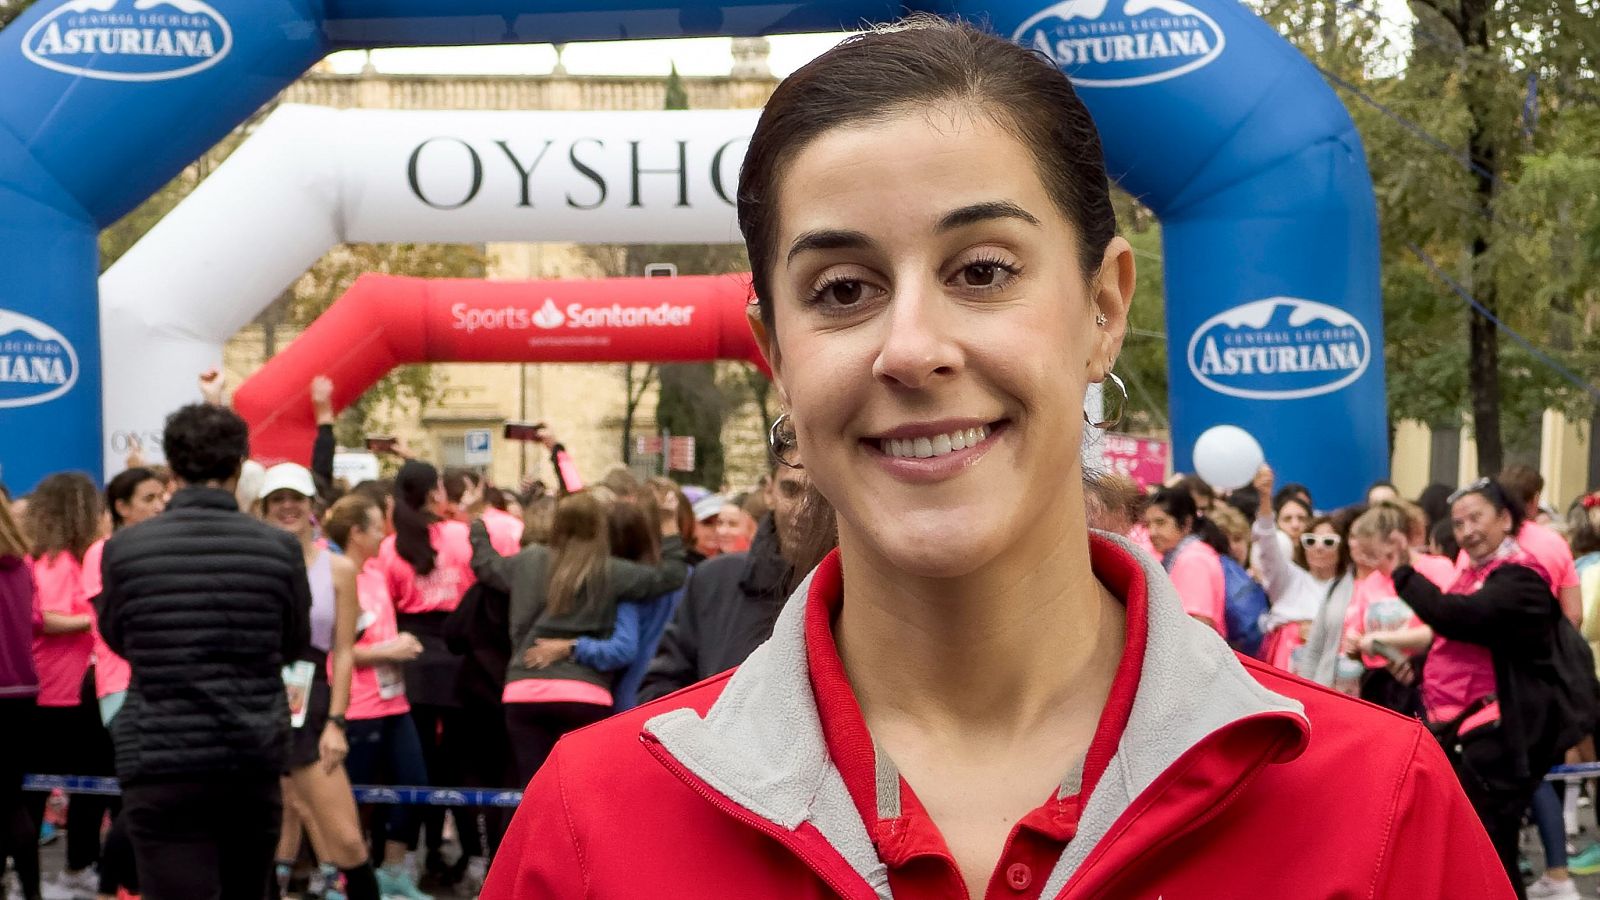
[1259,0,1600,472]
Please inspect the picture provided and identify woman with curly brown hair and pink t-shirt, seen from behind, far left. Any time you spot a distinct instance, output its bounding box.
[27,472,114,894]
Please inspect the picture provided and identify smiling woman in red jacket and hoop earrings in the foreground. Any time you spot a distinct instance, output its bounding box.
[483,19,1512,900]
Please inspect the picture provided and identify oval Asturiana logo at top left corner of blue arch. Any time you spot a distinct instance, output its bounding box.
[22,0,234,82]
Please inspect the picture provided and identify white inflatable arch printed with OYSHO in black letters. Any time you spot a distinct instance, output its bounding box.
[99,106,760,476]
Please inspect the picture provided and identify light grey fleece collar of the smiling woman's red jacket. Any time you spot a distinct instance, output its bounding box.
[645,535,1304,900]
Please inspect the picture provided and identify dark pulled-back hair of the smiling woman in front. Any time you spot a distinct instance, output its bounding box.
[739,16,1117,331]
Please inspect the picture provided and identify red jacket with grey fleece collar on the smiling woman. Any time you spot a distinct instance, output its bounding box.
[482,538,1512,900]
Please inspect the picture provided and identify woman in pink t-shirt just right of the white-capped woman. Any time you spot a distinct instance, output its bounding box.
[323,493,429,897]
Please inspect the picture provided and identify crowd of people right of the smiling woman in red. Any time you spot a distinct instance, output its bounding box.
[1099,466,1600,898]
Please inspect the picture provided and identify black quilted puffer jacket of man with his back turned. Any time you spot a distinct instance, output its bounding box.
[99,487,310,781]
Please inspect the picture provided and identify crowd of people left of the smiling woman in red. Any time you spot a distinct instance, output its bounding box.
[0,373,803,900]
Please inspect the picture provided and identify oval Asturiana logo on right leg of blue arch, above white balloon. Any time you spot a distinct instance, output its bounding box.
[1187,296,1373,400]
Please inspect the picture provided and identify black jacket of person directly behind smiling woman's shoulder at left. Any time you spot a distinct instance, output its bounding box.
[638,516,795,703]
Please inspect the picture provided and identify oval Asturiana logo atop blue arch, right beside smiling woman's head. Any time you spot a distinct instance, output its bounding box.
[1011,0,1227,88]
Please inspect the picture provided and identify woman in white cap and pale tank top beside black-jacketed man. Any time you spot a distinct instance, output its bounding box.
[258,463,388,900]
